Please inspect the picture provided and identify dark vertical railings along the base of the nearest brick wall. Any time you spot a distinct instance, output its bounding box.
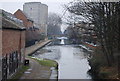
[2,51,21,81]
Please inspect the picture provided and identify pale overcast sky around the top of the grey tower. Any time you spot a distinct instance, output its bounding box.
[0,0,72,14]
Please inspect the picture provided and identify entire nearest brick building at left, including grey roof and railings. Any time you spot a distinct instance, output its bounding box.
[0,10,25,79]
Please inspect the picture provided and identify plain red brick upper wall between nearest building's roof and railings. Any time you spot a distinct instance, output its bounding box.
[2,30,25,56]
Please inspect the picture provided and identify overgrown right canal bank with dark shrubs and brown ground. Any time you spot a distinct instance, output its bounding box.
[80,43,120,81]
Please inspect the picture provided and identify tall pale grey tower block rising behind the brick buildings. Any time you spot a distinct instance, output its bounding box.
[23,2,48,36]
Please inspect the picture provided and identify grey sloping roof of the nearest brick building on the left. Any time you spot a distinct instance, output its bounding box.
[0,10,25,30]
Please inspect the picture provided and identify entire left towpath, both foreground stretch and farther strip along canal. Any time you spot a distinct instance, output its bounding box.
[20,40,51,79]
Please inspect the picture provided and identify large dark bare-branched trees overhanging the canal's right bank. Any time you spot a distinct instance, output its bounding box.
[66,1,120,65]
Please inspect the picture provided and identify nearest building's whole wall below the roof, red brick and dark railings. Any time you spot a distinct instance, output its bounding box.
[0,29,25,79]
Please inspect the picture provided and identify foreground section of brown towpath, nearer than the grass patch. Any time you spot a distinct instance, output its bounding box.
[20,59,51,79]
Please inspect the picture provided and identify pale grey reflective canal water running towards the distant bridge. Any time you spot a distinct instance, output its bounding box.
[33,40,91,79]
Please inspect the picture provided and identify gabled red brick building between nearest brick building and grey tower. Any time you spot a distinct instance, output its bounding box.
[14,9,39,46]
